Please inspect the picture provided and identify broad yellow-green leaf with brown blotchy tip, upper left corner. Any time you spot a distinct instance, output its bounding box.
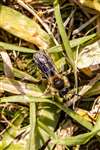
[0,5,52,49]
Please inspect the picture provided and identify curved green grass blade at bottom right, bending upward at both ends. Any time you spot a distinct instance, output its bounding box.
[38,121,99,146]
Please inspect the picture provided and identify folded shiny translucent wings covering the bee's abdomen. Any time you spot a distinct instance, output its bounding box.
[34,51,56,77]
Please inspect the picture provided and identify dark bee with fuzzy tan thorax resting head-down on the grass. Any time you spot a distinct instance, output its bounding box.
[33,51,68,97]
